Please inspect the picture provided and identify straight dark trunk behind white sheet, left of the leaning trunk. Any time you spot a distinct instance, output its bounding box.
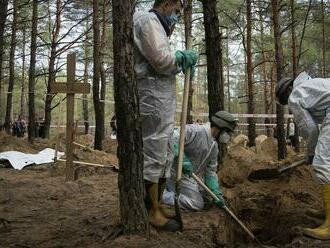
[28,0,38,142]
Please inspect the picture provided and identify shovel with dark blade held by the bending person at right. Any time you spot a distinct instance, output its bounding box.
[248,159,307,180]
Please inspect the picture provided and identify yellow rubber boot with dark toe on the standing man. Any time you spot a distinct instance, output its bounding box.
[147,183,180,232]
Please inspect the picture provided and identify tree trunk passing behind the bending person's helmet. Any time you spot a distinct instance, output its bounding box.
[272,0,287,159]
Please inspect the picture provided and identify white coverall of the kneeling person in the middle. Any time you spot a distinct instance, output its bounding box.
[163,123,219,210]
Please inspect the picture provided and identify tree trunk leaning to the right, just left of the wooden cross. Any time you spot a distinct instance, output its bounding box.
[43,0,62,138]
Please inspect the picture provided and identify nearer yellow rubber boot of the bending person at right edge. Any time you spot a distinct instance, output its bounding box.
[304,184,330,240]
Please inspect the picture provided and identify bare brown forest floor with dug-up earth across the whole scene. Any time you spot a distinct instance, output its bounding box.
[0,133,330,248]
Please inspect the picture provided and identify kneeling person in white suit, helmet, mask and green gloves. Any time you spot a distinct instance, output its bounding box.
[163,111,237,211]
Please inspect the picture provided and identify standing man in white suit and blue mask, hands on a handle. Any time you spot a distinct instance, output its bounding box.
[133,0,198,231]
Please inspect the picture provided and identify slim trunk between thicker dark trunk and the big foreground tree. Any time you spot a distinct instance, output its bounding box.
[100,0,109,140]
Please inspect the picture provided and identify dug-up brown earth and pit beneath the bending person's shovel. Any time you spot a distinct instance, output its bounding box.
[219,138,322,247]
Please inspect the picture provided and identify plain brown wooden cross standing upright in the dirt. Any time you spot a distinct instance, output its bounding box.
[50,53,90,181]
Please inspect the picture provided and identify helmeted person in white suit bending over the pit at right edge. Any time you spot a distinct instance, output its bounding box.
[276,72,330,239]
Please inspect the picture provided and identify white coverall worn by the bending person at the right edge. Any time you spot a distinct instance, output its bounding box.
[288,72,330,184]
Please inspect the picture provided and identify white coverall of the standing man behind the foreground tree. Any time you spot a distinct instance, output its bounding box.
[133,12,179,183]
